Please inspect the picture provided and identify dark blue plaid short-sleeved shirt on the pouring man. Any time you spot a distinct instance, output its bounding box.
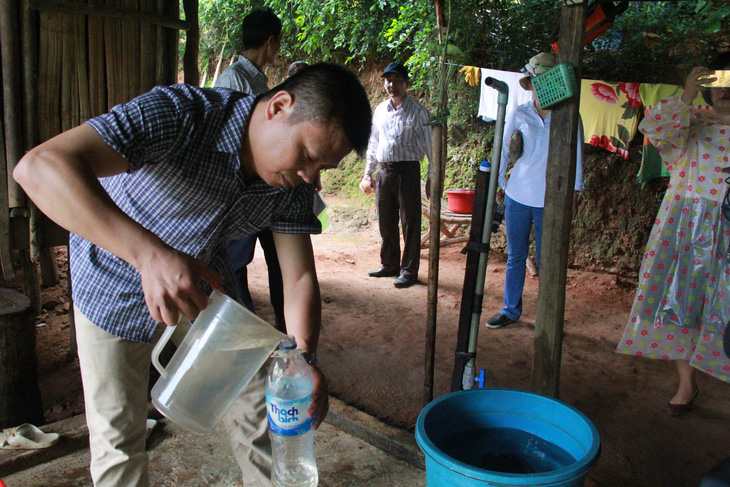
[69,85,321,342]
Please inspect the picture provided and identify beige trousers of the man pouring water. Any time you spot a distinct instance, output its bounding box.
[74,310,271,487]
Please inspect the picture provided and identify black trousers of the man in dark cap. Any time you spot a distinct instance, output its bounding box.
[375,161,421,278]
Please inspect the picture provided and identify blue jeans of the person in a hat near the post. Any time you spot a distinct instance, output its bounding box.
[499,195,543,321]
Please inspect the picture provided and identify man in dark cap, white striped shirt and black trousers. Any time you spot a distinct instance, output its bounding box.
[360,63,432,288]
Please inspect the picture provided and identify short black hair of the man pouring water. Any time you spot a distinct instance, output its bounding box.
[257,63,372,156]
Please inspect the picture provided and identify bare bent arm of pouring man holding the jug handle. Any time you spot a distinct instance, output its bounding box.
[13,125,220,325]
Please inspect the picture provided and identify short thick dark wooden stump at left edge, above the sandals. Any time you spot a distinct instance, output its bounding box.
[0,289,45,430]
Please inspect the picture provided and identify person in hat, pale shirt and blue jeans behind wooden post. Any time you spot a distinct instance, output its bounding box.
[486,53,583,328]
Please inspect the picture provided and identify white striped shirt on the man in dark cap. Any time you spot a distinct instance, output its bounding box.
[365,96,432,174]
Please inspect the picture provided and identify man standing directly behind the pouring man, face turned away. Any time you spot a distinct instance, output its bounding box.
[214,10,286,331]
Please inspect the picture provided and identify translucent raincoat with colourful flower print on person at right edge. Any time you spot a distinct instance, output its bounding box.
[616,97,730,382]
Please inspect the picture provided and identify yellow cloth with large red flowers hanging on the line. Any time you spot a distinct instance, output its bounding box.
[580,79,641,159]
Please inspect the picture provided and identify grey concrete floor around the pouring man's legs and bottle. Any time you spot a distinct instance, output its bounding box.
[0,400,426,487]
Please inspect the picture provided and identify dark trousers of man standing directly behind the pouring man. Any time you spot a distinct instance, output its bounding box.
[227,230,286,332]
